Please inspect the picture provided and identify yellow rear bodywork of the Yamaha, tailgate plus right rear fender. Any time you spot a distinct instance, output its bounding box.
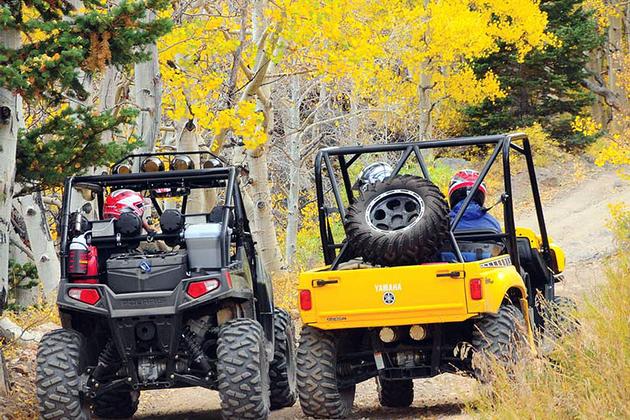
[298,256,526,329]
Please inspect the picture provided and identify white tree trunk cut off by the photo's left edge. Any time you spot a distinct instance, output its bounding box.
[0,29,22,307]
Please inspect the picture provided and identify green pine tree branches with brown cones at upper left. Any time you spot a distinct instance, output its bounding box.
[0,0,170,191]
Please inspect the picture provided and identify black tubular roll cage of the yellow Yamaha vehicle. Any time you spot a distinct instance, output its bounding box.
[315,133,551,272]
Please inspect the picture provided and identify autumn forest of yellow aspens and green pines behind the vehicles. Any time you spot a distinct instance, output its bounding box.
[0,0,630,310]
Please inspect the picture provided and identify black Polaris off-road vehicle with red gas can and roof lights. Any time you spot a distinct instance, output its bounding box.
[37,152,297,419]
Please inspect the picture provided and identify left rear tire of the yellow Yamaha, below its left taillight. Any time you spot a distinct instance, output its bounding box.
[297,327,356,419]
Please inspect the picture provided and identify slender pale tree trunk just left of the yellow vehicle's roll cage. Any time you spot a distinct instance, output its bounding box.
[284,76,302,269]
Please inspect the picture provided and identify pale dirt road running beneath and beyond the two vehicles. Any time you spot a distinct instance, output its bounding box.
[137,168,630,420]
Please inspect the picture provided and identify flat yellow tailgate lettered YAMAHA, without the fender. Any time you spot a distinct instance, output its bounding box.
[299,264,473,329]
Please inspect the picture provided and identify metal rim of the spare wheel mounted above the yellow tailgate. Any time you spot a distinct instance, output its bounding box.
[365,189,425,233]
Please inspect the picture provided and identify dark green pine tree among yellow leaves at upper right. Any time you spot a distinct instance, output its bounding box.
[466,0,603,145]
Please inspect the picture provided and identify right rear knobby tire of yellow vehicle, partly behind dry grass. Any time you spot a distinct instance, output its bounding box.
[472,303,527,382]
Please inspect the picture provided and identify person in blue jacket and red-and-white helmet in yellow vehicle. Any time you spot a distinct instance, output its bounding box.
[448,169,501,233]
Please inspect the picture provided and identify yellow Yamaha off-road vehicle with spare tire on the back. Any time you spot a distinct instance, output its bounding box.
[297,134,571,418]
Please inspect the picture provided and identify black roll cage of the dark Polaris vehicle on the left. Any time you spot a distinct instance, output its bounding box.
[60,156,251,281]
